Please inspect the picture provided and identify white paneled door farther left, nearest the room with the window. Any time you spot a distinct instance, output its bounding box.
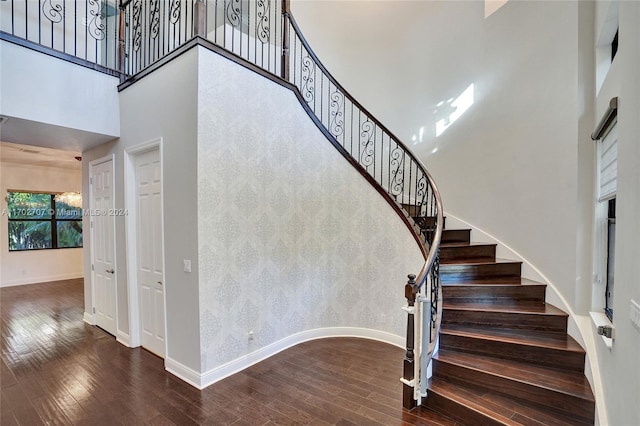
[89,160,117,335]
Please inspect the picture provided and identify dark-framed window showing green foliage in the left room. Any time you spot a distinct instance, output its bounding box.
[7,192,82,251]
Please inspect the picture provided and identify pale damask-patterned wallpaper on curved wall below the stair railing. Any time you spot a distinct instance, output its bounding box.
[197,48,422,372]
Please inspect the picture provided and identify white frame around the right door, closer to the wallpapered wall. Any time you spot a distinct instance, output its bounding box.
[124,138,169,359]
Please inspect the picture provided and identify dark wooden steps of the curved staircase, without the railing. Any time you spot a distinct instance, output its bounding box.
[423,229,595,425]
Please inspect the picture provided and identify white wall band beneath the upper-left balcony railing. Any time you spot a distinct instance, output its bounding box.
[0,41,120,137]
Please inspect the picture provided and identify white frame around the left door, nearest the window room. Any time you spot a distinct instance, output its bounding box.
[89,154,120,337]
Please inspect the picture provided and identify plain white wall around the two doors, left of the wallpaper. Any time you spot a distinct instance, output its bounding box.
[83,50,200,370]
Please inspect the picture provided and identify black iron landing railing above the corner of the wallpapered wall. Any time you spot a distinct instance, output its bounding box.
[122,0,282,76]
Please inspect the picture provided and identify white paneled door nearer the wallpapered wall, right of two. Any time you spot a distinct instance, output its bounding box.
[135,149,165,358]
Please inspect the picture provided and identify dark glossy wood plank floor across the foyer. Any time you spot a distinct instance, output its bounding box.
[0,280,456,426]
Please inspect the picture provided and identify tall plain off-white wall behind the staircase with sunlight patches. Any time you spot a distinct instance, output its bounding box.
[292,1,579,312]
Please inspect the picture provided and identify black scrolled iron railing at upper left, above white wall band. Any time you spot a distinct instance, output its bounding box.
[0,0,118,70]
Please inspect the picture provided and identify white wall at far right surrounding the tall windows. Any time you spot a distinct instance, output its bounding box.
[587,1,640,426]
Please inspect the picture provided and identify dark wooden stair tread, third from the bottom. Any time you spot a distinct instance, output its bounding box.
[440,324,584,354]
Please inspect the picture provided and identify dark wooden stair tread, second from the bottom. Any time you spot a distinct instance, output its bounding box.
[434,349,595,402]
